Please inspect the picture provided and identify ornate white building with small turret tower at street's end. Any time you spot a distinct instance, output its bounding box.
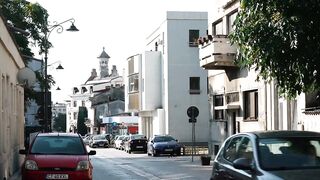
[67,48,123,134]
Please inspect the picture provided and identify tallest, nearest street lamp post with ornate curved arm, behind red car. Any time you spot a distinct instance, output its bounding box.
[43,18,79,132]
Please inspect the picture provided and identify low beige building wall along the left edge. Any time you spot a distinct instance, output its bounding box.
[0,14,25,179]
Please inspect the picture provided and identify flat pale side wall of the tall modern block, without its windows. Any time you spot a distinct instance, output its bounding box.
[146,12,209,142]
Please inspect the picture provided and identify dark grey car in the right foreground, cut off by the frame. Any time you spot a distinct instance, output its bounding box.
[211,131,320,180]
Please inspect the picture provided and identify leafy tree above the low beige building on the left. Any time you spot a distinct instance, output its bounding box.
[0,0,55,107]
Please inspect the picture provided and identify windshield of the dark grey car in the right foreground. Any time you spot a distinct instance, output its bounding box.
[258,137,320,170]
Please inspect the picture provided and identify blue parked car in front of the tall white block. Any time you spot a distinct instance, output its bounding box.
[147,135,181,156]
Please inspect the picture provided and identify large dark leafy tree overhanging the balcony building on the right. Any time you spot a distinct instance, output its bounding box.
[229,0,320,98]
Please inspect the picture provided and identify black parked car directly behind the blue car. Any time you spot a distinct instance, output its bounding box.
[123,134,148,154]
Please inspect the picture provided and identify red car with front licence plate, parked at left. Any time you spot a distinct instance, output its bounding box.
[19,133,96,180]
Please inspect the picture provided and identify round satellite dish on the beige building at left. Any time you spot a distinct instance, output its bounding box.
[18,67,36,88]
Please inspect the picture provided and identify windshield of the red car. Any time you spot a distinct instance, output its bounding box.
[30,136,86,155]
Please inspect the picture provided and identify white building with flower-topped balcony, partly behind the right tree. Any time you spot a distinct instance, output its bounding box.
[199,0,320,153]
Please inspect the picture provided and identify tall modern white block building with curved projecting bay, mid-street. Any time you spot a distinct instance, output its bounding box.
[126,11,210,143]
